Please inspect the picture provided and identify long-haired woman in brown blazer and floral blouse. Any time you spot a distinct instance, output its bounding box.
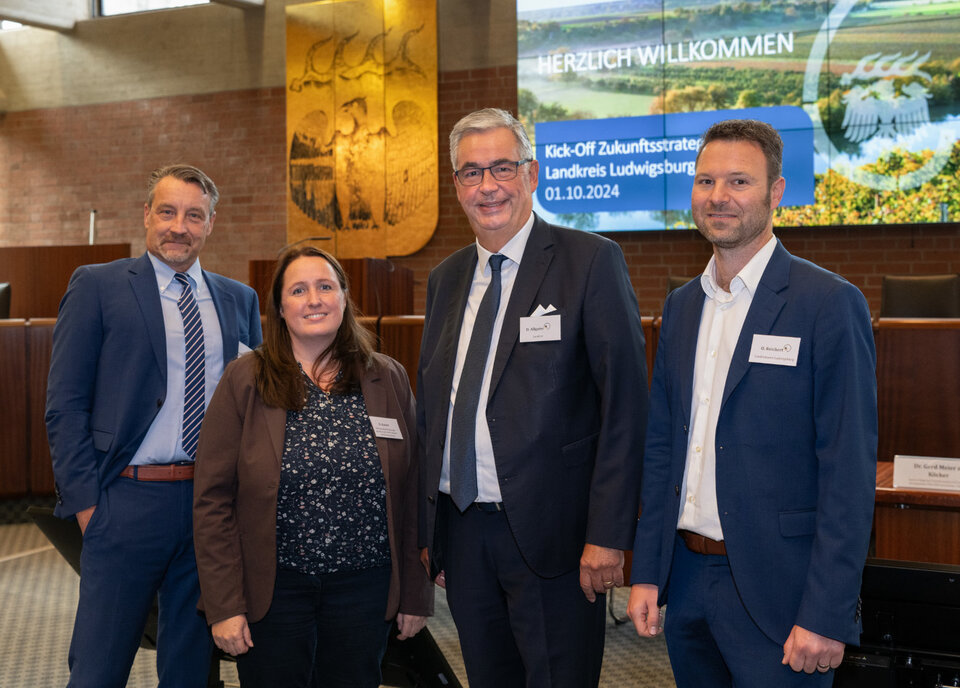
[193,246,433,688]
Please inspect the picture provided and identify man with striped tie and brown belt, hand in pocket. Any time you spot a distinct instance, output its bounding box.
[46,165,261,688]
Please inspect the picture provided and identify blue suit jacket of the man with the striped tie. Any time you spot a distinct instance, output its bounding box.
[46,254,261,517]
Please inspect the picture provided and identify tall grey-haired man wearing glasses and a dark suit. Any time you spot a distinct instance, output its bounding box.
[417,109,647,688]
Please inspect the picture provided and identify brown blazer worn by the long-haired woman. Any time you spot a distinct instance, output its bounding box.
[193,354,433,624]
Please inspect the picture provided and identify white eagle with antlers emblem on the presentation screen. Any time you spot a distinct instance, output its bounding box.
[840,51,932,143]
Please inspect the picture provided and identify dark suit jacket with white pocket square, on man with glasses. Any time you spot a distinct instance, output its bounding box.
[417,218,647,577]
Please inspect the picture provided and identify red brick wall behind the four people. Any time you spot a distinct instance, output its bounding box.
[0,66,960,314]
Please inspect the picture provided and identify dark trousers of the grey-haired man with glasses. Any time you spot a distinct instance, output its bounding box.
[438,494,606,688]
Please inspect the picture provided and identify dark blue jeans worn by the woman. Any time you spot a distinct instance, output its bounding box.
[237,566,390,688]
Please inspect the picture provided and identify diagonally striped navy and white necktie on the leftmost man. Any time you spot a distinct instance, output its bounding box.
[174,272,206,459]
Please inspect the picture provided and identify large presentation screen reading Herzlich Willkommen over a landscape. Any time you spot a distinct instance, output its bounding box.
[517,0,960,231]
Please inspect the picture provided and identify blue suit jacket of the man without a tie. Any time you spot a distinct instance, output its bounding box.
[631,244,877,643]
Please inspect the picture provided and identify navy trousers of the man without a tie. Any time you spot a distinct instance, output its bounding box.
[664,536,833,688]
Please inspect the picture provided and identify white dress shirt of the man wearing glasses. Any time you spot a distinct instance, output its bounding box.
[440,213,533,502]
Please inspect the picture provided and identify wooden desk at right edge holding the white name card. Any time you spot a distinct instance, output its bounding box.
[874,461,960,565]
